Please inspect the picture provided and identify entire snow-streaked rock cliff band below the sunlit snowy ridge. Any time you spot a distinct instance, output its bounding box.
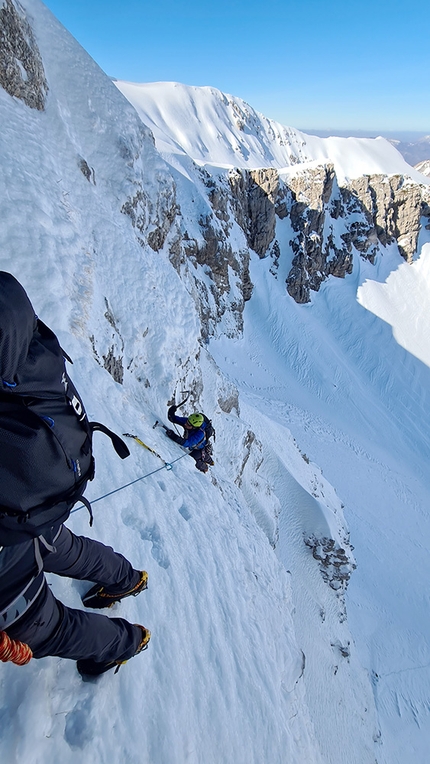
[121,121,430,322]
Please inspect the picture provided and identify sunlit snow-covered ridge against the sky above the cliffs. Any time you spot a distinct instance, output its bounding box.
[115,81,428,183]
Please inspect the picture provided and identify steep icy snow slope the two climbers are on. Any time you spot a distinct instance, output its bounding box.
[0,0,371,764]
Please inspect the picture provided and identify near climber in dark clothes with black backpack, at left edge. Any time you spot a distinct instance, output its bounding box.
[0,272,150,676]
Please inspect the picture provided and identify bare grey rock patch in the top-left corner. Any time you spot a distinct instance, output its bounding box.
[0,0,48,111]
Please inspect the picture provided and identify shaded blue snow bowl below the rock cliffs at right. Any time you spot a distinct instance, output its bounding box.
[211,237,430,764]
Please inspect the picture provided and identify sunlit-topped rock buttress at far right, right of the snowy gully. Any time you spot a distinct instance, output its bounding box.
[286,165,430,303]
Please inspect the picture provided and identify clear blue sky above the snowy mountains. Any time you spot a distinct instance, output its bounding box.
[45,0,430,134]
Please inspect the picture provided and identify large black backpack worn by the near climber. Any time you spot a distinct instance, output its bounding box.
[0,272,130,547]
